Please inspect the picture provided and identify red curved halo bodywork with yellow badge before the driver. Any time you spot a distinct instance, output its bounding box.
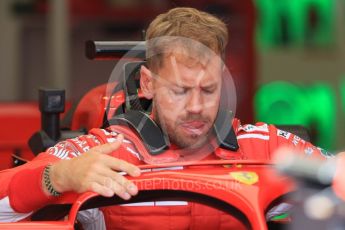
[0,160,294,230]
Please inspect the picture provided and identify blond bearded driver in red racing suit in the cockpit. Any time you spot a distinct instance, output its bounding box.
[0,8,328,229]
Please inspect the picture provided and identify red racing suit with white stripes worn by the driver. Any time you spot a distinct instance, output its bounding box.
[0,119,331,229]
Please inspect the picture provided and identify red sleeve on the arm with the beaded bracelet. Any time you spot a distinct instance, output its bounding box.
[0,135,100,217]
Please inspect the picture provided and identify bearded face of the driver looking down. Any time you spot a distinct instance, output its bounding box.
[148,53,222,149]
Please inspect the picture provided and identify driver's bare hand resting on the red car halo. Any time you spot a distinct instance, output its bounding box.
[44,135,140,200]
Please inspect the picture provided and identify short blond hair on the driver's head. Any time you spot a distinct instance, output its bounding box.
[146,7,228,69]
